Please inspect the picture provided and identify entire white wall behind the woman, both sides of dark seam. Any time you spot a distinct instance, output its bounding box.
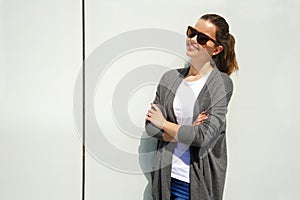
[0,0,300,200]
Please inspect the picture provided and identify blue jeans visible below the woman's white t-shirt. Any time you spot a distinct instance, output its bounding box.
[171,178,190,200]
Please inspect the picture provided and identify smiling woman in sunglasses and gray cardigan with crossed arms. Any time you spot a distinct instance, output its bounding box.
[145,14,238,200]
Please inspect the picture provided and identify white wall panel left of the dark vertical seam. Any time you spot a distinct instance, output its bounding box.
[0,0,81,200]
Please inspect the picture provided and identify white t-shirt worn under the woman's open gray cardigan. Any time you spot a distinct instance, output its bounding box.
[171,73,210,183]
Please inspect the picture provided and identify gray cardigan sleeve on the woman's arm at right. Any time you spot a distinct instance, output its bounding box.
[178,76,233,147]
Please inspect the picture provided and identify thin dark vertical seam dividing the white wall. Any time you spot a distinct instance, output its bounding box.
[82,0,85,200]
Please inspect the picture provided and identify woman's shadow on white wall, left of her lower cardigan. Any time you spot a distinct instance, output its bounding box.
[139,131,157,200]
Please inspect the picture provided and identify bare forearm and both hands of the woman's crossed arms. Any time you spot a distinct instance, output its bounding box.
[146,103,208,142]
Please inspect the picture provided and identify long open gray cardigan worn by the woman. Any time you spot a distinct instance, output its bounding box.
[145,67,233,200]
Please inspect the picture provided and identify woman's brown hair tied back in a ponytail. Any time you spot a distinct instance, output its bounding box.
[200,14,239,75]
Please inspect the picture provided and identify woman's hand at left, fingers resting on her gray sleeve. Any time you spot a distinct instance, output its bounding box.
[146,103,167,129]
